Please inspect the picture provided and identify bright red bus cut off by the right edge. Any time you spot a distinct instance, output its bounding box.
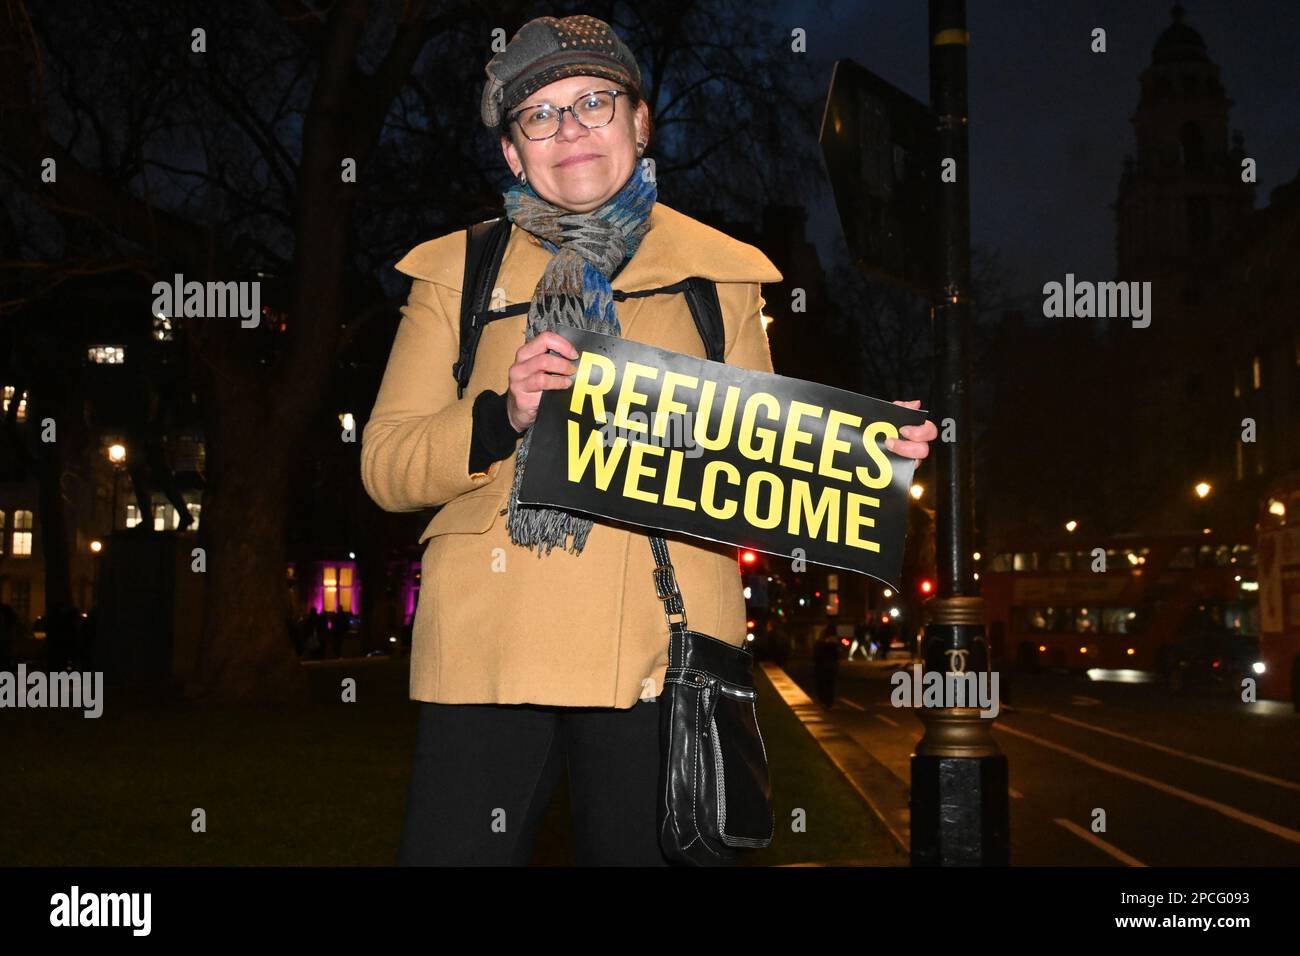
[1257,472,1300,710]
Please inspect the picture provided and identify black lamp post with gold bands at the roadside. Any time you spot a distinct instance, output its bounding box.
[911,0,1010,866]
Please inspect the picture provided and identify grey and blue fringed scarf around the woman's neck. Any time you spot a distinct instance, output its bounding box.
[504,165,658,558]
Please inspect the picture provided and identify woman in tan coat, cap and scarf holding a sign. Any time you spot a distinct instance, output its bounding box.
[361,16,935,866]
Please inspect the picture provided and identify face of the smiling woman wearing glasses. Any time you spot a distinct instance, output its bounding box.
[501,77,650,212]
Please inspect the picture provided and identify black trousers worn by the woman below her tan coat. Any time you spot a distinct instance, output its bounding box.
[398,700,671,866]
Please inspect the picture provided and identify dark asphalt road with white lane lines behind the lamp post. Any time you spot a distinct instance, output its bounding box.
[787,661,1300,866]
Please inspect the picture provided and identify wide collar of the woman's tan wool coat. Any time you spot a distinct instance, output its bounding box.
[394,202,781,293]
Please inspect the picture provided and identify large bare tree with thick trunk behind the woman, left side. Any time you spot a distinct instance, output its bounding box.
[0,0,815,698]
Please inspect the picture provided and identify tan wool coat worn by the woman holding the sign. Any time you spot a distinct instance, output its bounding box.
[361,203,781,708]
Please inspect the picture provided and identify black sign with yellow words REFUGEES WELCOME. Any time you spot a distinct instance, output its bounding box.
[519,328,926,587]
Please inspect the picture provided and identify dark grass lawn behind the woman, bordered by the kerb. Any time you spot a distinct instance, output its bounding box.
[0,659,894,866]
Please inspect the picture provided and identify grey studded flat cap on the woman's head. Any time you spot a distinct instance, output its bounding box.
[481,14,641,129]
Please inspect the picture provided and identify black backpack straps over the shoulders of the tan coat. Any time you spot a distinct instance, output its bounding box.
[451,216,727,398]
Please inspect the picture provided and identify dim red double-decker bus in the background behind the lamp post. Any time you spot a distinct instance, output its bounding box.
[978,533,1257,680]
